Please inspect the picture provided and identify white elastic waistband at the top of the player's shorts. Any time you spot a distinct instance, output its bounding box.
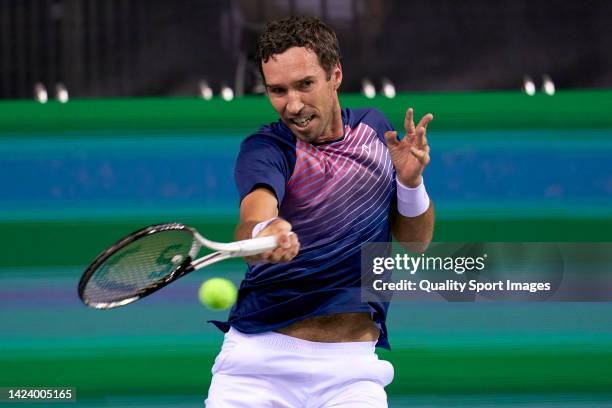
[226,327,376,355]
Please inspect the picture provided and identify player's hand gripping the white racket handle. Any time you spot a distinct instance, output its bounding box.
[244,218,300,263]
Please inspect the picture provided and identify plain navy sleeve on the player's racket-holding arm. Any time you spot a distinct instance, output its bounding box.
[234,135,289,205]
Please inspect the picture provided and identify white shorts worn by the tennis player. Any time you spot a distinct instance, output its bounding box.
[205,328,393,408]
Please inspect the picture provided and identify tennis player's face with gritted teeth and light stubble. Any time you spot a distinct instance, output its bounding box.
[262,47,342,143]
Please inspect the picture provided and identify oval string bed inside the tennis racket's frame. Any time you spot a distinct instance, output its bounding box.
[84,230,194,304]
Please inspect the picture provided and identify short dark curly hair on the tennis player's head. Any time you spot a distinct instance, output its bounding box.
[255,16,340,80]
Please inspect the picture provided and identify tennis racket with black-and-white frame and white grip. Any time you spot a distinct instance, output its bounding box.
[78,223,277,309]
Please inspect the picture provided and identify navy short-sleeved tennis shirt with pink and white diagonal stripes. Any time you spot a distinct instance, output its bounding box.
[215,109,396,348]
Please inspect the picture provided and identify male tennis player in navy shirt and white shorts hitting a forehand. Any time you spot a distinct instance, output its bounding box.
[206,17,434,408]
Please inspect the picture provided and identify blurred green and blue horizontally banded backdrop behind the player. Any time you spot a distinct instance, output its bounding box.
[0,91,612,407]
